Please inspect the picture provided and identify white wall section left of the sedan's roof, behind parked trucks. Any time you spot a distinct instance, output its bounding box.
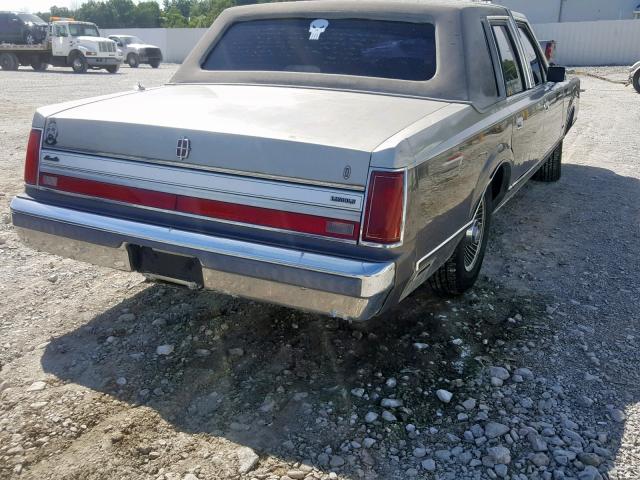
[101,28,207,63]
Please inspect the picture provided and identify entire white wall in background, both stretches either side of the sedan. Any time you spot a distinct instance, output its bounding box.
[102,21,640,66]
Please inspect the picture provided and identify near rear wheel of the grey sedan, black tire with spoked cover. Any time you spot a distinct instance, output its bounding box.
[429,188,493,296]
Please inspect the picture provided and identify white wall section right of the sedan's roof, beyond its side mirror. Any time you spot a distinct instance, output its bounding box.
[534,20,640,67]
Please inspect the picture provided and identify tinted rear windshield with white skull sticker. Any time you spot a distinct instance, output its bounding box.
[202,18,436,81]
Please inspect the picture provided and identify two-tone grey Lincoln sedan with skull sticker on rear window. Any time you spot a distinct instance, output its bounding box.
[11,0,580,320]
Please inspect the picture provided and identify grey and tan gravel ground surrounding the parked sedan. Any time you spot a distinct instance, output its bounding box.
[0,66,640,480]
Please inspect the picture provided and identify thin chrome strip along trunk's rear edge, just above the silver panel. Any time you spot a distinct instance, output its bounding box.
[41,146,365,192]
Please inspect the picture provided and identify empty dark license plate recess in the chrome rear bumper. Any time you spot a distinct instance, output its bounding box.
[127,245,204,288]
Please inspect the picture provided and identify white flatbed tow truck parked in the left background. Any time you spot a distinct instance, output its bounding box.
[0,17,124,73]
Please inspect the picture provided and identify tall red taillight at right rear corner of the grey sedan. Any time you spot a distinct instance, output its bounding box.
[362,172,404,245]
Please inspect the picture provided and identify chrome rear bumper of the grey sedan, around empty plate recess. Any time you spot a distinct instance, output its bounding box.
[11,196,396,320]
